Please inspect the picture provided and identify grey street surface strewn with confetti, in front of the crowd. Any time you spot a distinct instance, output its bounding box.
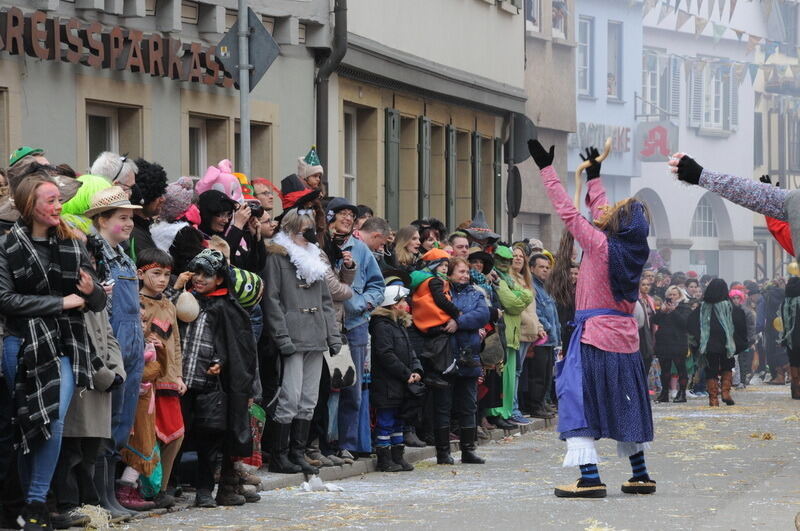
[127,385,800,531]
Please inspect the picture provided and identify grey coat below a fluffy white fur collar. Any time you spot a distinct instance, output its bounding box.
[263,242,342,356]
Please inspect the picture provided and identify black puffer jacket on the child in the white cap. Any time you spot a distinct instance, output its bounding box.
[369,308,424,408]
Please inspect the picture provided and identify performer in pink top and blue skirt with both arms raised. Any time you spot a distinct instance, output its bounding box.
[528,140,656,498]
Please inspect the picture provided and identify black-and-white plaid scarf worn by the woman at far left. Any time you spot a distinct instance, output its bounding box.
[5,221,102,453]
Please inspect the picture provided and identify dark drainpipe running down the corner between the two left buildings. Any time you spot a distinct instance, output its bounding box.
[314,0,347,182]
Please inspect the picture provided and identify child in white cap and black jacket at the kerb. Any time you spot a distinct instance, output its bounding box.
[369,286,423,472]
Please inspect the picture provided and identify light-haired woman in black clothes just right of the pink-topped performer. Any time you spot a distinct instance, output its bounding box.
[653,286,692,402]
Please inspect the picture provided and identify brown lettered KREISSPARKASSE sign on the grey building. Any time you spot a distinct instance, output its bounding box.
[0,7,233,87]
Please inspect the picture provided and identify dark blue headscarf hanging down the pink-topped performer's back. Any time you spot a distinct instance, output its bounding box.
[608,203,650,302]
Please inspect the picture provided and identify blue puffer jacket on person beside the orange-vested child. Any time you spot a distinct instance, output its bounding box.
[450,282,489,378]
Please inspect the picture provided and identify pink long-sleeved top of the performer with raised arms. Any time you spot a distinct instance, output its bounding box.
[541,166,639,353]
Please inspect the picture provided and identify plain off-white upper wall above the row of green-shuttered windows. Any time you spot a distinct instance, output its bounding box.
[347,0,525,88]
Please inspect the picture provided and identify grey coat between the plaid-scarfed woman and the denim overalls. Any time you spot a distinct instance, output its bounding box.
[64,310,125,439]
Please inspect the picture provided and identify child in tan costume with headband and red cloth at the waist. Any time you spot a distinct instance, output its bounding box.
[136,248,186,507]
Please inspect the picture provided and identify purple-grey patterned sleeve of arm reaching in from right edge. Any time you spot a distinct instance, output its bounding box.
[699,170,788,221]
